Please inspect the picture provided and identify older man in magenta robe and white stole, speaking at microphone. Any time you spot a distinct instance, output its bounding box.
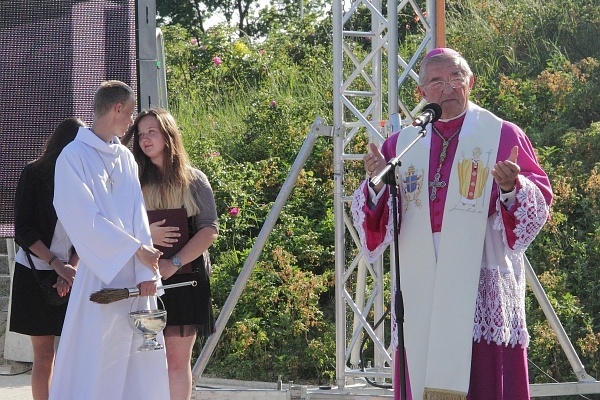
[352,48,552,400]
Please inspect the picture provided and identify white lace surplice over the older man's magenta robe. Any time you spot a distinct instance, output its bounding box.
[351,176,549,347]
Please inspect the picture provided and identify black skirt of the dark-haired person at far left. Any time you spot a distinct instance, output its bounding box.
[10,263,67,336]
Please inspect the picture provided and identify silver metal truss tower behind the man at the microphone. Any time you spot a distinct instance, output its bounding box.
[333,0,443,388]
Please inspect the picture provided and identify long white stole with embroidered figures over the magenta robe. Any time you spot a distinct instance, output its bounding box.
[396,103,502,400]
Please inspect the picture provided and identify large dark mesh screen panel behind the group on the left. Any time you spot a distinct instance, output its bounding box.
[0,0,137,237]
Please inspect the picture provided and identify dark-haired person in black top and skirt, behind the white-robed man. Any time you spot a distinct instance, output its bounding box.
[10,118,85,400]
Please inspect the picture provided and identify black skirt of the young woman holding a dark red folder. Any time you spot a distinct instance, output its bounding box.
[160,257,215,338]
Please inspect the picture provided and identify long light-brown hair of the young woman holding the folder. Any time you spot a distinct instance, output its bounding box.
[122,107,200,216]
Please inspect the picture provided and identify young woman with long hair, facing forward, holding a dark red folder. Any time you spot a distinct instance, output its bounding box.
[122,108,218,400]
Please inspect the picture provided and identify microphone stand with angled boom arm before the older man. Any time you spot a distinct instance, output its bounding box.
[369,126,427,400]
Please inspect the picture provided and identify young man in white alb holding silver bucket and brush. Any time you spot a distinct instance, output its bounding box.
[50,81,169,400]
